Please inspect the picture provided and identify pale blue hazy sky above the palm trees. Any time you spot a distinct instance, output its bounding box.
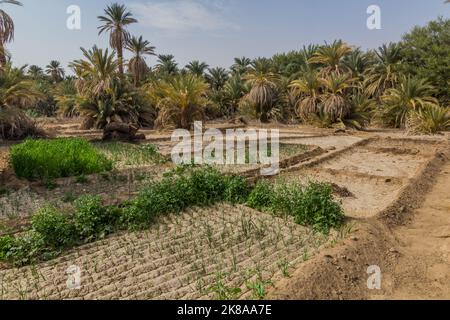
[4,0,450,71]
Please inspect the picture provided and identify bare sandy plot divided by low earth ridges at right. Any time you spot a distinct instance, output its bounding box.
[282,139,437,218]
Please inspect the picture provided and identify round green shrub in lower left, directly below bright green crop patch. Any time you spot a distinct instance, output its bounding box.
[31,206,76,248]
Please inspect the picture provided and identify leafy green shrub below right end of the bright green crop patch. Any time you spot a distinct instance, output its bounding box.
[74,196,121,241]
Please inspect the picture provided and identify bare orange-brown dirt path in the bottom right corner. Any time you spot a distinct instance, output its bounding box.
[370,162,450,299]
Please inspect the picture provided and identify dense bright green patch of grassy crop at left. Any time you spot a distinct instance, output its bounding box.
[11,138,112,180]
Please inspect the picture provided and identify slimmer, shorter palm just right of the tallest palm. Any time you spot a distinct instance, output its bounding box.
[126,36,156,87]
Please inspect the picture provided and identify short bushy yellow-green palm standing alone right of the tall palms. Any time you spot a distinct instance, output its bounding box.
[149,74,209,129]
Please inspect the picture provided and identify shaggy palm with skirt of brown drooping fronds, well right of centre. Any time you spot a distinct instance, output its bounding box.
[321,73,355,123]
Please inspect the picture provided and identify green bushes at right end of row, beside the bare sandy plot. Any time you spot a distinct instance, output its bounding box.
[247,181,344,233]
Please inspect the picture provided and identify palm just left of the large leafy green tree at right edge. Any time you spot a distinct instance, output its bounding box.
[364,43,402,98]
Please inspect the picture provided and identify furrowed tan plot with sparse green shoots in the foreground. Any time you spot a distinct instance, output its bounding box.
[0,205,329,299]
